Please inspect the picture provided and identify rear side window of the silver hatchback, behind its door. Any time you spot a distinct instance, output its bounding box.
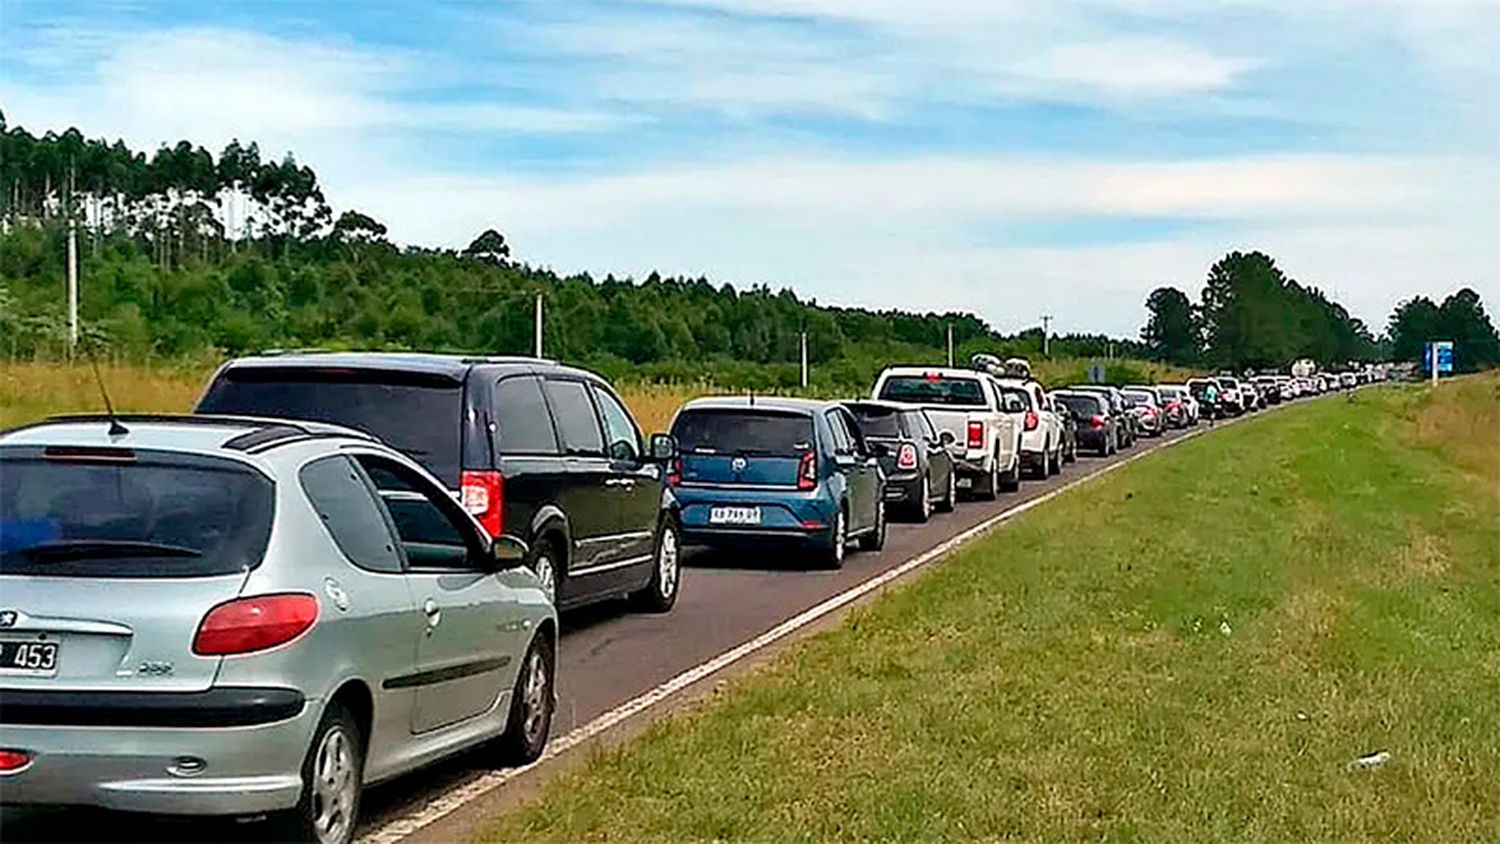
[299,457,401,573]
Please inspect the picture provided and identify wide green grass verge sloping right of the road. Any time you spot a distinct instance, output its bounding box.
[477,376,1500,843]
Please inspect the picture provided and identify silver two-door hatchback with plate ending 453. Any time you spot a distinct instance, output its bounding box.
[0,417,558,844]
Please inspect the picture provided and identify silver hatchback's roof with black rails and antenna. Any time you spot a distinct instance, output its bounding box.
[0,414,375,454]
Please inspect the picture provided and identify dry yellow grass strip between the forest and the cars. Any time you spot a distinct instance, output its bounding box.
[0,360,1188,433]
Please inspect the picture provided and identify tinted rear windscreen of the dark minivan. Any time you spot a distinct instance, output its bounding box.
[197,367,464,489]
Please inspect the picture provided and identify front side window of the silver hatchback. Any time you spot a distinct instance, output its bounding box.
[357,454,474,568]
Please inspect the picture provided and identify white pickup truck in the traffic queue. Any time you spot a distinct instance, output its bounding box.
[872,366,1025,499]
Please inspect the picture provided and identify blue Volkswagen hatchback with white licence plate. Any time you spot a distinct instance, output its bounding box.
[669,397,885,567]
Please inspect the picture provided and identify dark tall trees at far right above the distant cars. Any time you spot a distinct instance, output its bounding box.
[1142,252,1500,372]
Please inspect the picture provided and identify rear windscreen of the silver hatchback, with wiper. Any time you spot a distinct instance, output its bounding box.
[0,450,275,577]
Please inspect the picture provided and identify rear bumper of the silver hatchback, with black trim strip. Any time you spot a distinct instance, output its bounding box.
[0,690,318,816]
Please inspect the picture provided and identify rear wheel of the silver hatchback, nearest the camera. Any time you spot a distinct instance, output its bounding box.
[275,700,365,844]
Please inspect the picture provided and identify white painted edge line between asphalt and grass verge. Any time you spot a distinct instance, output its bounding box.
[359,428,1218,844]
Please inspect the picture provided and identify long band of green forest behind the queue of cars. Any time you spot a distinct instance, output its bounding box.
[0,114,1493,388]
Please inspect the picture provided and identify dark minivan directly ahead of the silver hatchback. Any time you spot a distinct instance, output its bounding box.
[197,352,681,612]
